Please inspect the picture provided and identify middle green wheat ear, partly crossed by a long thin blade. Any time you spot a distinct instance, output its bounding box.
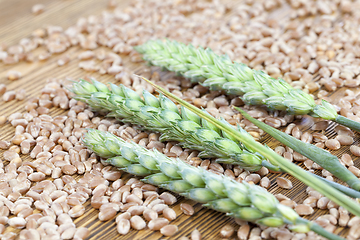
[70,80,271,171]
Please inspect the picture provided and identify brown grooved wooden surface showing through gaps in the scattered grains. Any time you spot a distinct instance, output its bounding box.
[0,0,360,240]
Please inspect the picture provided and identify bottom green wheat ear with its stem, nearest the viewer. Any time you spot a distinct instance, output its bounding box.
[83,129,342,239]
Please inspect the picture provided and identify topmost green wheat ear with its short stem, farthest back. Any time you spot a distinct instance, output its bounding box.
[135,40,360,132]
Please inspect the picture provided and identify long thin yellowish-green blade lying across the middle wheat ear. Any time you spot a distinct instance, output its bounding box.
[142,78,360,216]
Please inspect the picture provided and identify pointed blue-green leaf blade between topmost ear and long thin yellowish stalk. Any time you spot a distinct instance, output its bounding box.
[235,107,360,191]
